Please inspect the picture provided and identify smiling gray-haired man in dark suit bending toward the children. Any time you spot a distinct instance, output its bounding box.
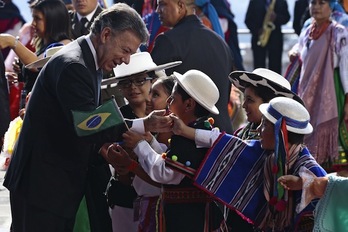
[4,4,166,232]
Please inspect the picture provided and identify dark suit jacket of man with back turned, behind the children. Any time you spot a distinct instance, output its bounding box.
[151,15,233,133]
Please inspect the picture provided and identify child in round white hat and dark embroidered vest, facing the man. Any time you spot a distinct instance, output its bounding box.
[102,70,223,232]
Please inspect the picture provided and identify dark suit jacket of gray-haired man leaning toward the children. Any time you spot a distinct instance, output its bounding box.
[4,37,124,218]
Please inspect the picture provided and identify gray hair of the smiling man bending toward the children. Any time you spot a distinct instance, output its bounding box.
[91,3,149,44]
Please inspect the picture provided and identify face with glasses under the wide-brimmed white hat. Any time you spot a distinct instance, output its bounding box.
[118,73,151,105]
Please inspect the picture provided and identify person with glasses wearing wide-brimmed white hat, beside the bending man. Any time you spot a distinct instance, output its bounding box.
[102,52,181,232]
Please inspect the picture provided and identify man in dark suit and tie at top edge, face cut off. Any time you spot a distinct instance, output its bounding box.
[69,0,103,39]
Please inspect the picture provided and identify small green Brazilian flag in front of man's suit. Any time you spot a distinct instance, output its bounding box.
[72,98,125,137]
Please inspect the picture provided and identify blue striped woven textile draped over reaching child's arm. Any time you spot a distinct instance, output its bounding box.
[194,134,267,224]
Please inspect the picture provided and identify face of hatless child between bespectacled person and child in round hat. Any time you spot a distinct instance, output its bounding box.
[150,81,169,110]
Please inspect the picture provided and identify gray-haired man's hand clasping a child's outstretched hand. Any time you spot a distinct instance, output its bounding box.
[144,110,173,132]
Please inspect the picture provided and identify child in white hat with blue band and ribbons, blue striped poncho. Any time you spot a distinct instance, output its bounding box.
[173,97,326,231]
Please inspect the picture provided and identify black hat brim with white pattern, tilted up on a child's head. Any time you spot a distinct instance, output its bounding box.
[228,71,304,105]
